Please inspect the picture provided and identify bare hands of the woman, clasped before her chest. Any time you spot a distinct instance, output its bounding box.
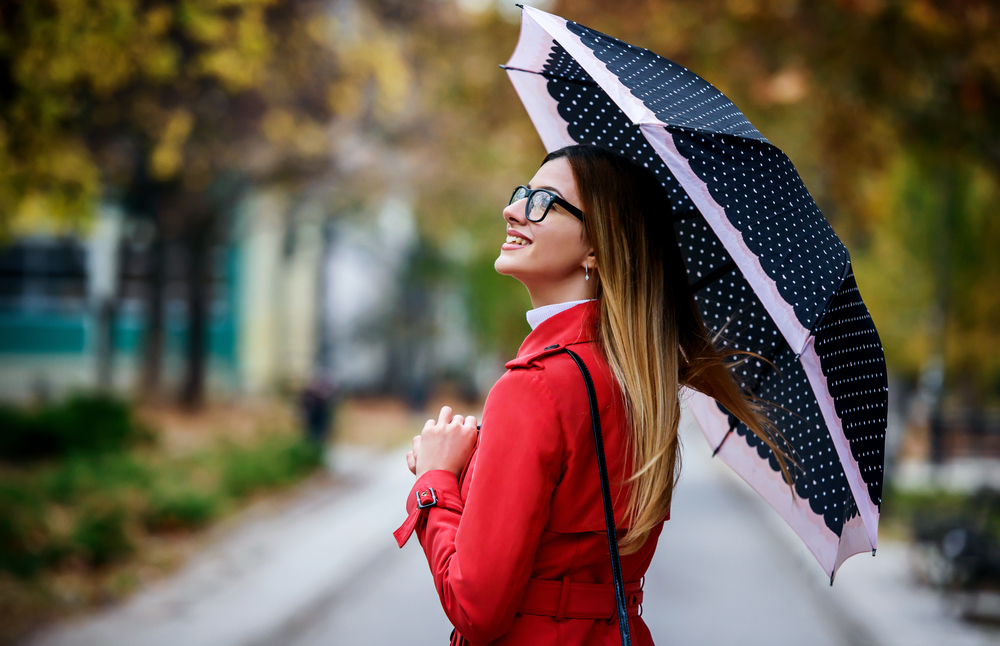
[406,406,477,478]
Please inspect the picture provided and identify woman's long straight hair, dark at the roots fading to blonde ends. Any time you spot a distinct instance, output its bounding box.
[542,145,792,554]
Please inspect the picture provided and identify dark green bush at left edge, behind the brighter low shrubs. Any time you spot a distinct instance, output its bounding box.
[0,395,150,460]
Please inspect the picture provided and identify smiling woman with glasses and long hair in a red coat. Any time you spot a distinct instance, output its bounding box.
[396,146,787,645]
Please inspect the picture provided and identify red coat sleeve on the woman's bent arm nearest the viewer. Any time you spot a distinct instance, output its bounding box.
[415,370,564,643]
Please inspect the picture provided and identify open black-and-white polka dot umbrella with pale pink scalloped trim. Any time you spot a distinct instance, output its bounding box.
[502,7,887,583]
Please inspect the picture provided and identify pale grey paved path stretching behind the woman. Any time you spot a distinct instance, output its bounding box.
[23,412,1000,646]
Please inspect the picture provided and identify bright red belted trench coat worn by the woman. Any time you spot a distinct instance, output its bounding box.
[396,301,669,646]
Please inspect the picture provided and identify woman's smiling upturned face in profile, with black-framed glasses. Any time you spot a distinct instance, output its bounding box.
[493,158,594,291]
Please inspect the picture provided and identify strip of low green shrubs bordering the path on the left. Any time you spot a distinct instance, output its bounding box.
[0,435,323,578]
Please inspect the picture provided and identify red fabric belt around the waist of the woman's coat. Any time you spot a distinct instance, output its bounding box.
[518,578,642,621]
